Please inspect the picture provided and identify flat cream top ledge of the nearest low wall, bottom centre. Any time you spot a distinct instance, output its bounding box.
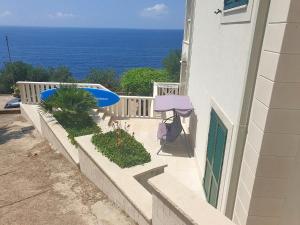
[149,173,234,225]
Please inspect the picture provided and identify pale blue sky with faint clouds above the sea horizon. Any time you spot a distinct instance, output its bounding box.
[0,0,185,29]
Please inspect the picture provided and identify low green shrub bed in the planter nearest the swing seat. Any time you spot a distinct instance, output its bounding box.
[92,129,151,168]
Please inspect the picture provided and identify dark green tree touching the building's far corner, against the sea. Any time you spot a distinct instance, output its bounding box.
[163,50,181,82]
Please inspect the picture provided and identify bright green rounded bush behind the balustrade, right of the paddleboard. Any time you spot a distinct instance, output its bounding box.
[121,68,168,96]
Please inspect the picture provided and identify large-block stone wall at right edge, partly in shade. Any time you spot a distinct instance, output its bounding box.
[234,0,300,225]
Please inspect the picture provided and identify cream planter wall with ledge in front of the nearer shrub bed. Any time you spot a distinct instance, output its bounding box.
[75,135,159,224]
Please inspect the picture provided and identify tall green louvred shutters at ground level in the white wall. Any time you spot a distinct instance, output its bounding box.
[203,109,228,207]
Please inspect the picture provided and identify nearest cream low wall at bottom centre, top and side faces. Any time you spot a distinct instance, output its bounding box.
[149,173,234,225]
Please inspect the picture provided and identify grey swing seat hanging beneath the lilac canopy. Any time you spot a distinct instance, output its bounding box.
[157,114,190,157]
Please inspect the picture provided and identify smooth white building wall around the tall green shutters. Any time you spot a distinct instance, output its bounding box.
[188,0,259,212]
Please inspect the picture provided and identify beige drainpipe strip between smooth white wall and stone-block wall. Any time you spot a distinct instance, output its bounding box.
[225,0,271,219]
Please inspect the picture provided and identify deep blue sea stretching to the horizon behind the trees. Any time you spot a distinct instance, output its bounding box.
[0,27,183,79]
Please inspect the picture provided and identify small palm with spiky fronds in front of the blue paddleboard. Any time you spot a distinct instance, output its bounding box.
[42,85,97,114]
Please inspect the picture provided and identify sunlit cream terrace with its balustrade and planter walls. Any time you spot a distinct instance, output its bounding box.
[17,82,234,224]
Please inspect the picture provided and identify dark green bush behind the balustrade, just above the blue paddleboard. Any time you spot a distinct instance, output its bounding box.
[85,69,120,91]
